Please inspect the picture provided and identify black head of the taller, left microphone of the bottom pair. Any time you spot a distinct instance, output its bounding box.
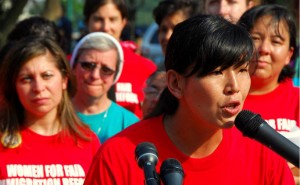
[135,142,158,168]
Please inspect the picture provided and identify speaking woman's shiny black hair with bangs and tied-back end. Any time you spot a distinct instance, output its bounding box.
[148,15,254,117]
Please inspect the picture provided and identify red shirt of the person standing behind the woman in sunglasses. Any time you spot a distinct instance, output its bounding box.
[115,43,157,118]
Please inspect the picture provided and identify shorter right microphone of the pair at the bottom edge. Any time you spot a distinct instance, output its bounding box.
[160,158,184,185]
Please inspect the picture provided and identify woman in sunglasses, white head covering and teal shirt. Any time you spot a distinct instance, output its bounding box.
[71,32,138,143]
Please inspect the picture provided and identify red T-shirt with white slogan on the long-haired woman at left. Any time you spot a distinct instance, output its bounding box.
[0,129,100,185]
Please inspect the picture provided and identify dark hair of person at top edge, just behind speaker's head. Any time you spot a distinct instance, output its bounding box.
[153,0,201,25]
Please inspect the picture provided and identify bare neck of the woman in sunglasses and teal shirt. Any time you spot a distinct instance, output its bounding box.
[73,96,111,114]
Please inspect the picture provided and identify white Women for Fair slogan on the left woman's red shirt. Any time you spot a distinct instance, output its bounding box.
[0,164,85,185]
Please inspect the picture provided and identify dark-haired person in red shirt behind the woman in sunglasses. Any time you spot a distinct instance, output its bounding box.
[83,0,157,118]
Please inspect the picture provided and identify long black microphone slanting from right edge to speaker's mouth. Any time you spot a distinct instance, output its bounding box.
[234,110,300,168]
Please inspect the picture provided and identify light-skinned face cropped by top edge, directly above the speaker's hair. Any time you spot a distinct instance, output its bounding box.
[204,0,253,23]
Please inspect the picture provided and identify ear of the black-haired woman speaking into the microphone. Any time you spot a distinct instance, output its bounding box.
[167,70,184,99]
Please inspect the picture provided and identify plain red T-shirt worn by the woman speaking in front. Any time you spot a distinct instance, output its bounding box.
[85,117,295,185]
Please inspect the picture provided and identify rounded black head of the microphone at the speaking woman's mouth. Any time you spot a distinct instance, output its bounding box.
[234,110,264,138]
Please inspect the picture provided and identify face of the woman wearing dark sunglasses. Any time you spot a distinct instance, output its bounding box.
[74,49,118,99]
